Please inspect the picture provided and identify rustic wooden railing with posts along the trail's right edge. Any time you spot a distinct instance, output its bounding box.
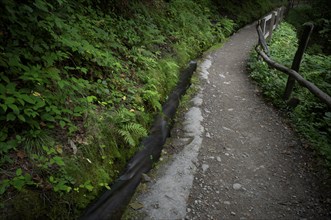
[255,8,331,108]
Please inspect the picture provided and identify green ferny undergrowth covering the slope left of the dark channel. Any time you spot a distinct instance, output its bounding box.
[0,0,282,219]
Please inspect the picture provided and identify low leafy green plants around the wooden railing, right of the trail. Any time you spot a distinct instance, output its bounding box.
[249,23,331,166]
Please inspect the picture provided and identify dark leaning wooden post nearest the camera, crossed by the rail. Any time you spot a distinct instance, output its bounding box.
[283,23,314,100]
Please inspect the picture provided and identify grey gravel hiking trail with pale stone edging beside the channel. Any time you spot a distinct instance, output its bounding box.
[125,22,331,219]
